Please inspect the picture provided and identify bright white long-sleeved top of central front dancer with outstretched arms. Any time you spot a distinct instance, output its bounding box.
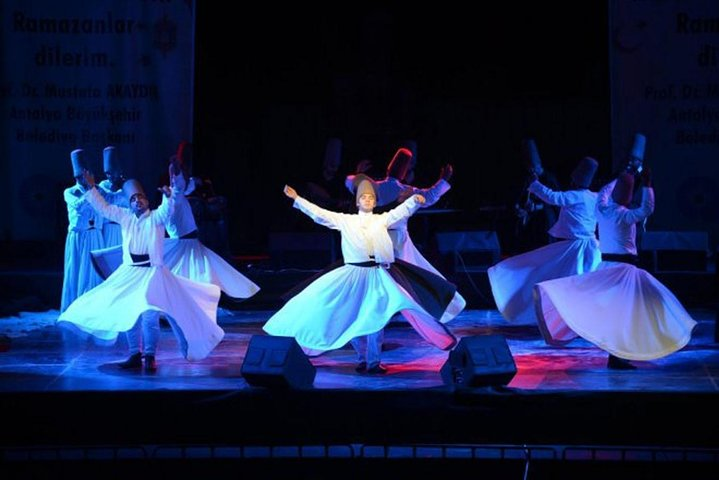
[293,195,420,263]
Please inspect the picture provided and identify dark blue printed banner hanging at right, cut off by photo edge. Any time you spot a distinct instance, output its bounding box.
[609,0,719,253]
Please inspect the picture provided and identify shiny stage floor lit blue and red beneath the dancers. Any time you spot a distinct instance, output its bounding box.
[0,309,719,392]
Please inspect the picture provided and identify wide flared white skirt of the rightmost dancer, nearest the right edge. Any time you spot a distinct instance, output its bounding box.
[534,262,696,360]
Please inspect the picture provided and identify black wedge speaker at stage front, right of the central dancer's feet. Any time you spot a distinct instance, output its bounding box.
[440,335,517,387]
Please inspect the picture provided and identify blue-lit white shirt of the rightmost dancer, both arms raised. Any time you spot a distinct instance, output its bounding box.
[597,180,654,255]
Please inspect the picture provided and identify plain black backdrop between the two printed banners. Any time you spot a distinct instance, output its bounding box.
[195,2,611,253]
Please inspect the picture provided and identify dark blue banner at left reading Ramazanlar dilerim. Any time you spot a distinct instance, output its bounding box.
[0,0,194,240]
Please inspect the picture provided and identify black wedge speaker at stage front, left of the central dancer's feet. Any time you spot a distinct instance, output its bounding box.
[241,335,316,389]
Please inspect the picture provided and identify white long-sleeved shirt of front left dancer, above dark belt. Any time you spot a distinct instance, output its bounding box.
[85,188,178,266]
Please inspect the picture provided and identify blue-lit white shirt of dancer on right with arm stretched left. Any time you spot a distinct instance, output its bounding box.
[529,180,597,240]
